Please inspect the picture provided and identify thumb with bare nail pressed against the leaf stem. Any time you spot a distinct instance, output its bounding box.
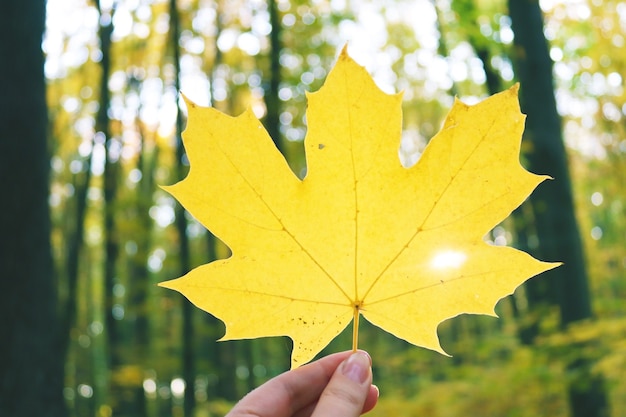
[311,351,372,417]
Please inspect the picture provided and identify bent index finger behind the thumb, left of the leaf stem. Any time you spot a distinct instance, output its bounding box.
[227,352,351,417]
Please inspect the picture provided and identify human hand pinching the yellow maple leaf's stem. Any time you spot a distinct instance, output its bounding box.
[226,351,378,417]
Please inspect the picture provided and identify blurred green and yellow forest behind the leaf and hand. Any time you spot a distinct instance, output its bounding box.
[0,0,626,417]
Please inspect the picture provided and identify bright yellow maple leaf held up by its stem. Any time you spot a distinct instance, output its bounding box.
[160,50,558,367]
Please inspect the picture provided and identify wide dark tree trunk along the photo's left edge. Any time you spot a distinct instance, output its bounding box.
[0,0,67,417]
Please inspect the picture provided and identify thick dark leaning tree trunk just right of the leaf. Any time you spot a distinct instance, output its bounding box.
[508,0,609,417]
